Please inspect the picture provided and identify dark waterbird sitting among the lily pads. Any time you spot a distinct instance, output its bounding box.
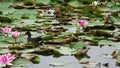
[25,31,43,45]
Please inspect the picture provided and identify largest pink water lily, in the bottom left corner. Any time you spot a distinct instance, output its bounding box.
[0,53,15,66]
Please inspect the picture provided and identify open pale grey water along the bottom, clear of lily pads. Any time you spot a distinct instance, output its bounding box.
[29,46,119,68]
